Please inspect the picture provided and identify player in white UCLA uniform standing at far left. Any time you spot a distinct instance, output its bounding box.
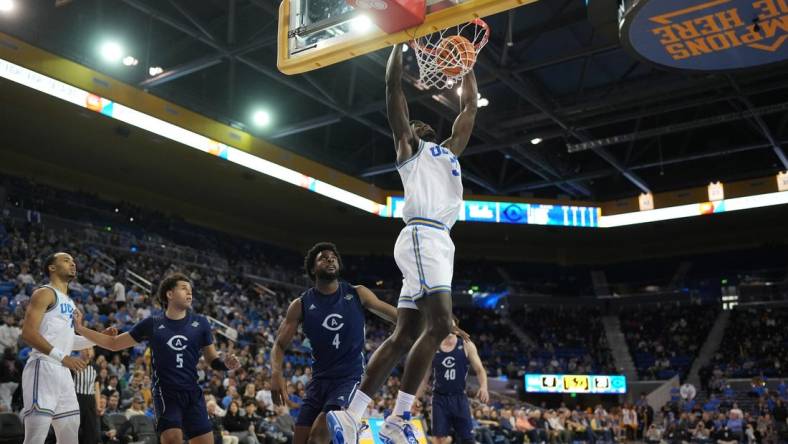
[22,252,93,444]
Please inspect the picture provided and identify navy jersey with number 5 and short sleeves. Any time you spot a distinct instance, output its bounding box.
[129,312,213,390]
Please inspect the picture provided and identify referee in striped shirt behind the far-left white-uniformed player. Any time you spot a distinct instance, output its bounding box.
[74,347,101,444]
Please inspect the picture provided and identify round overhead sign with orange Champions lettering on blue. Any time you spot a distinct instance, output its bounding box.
[620,0,788,71]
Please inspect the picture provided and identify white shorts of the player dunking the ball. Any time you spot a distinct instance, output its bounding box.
[394,223,454,310]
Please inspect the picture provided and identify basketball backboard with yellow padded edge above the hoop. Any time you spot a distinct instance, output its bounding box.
[277,0,538,74]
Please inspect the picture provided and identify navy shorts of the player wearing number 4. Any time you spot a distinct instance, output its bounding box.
[296,378,359,427]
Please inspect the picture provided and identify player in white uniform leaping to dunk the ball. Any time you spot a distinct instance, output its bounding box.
[327,45,477,444]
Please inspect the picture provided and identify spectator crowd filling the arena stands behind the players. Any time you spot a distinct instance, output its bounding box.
[0,175,788,444]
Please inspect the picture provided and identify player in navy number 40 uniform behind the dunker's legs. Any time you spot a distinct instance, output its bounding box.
[425,319,490,444]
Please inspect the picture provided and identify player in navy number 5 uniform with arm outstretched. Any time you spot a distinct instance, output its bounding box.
[74,273,240,444]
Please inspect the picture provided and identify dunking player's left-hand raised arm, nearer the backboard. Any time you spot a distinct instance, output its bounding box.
[386,45,418,164]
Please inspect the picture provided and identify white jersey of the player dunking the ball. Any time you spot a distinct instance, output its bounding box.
[397,140,462,229]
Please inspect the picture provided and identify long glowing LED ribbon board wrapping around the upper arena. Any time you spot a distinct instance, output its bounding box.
[0,55,788,228]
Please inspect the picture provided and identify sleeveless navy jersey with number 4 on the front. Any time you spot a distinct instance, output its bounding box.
[301,282,365,379]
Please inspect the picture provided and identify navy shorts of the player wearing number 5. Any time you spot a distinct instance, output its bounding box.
[153,388,213,440]
